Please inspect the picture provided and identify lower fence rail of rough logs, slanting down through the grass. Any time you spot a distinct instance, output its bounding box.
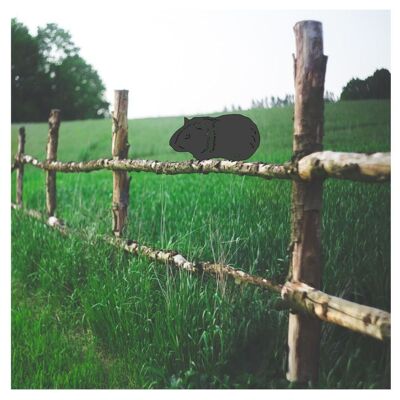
[12,204,391,340]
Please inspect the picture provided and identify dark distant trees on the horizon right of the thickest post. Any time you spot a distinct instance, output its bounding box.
[340,69,391,100]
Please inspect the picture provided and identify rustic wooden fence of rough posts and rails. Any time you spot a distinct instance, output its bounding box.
[11,21,391,382]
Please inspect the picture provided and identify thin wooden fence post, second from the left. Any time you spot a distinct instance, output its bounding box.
[46,110,60,217]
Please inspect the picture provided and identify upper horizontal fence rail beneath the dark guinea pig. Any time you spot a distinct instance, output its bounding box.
[11,151,390,182]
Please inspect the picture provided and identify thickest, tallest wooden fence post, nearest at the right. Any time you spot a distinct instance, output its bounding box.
[286,21,327,383]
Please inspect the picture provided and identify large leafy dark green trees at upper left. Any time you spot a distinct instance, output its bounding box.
[11,19,109,122]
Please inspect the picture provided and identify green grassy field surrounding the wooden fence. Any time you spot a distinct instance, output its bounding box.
[11,101,390,388]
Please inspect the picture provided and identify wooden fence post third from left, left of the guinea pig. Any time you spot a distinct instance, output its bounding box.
[112,90,130,237]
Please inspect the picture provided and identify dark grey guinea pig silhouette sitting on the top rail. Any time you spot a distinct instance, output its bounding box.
[169,114,260,161]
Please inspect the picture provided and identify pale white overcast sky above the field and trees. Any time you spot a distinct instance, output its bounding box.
[10,2,390,118]
